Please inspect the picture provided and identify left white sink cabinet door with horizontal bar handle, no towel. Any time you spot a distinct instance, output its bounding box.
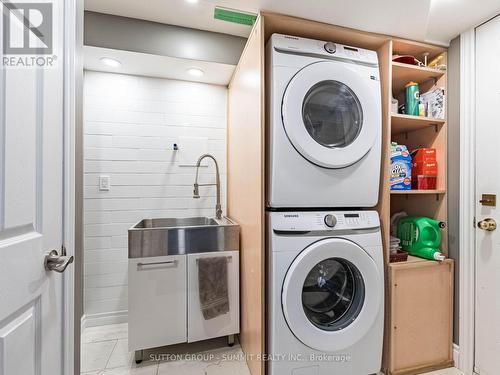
[128,255,187,351]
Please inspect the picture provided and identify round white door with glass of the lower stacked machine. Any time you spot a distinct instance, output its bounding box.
[281,238,383,352]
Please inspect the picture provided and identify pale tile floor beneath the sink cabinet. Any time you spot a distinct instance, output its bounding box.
[81,323,464,375]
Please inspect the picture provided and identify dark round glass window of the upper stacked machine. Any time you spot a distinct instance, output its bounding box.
[302,81,363,148]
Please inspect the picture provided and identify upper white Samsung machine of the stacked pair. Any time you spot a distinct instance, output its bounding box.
[266,34,382,208]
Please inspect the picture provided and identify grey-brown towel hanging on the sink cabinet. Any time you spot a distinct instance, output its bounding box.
[197,256,229,320]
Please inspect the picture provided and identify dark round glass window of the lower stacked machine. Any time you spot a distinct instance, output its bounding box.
[302,258,365,331]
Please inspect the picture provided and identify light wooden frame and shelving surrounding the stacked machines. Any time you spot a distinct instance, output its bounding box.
[227,12,451,375]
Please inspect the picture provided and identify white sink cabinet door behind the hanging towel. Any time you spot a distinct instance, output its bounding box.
[188,251,240,342]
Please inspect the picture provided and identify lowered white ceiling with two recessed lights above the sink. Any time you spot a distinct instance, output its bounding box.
[83,46,235,86]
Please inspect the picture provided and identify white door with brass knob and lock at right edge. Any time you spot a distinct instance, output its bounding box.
[475,13,500,375]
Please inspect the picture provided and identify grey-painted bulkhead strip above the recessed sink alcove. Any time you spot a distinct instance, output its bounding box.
[84,12,246,65]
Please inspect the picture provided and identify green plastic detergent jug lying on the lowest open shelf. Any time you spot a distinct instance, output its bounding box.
[398,216,446,261]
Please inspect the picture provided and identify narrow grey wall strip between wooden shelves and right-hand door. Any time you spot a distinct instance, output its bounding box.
[448,37,460,345]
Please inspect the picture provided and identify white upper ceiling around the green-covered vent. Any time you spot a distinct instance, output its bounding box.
[85,0,500,45]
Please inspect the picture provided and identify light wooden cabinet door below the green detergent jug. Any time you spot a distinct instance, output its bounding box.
[389,258,453,374]
